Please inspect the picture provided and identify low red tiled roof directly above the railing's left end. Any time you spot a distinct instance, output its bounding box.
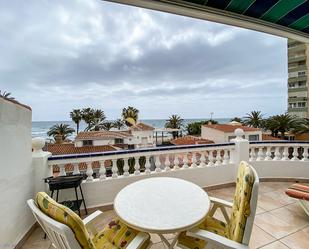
[43,143,117,155]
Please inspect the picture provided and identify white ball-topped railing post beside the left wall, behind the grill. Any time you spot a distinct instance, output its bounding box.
[32,137,53,193]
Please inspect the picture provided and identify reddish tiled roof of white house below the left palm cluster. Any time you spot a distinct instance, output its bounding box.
[75,131,132,140]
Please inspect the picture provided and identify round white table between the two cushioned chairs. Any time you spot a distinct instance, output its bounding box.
[114,177,210,248]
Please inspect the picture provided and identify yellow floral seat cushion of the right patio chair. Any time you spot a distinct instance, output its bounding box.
[178,216,227,249]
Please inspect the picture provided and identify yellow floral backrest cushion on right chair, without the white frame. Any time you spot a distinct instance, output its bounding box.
[228,162,254,242]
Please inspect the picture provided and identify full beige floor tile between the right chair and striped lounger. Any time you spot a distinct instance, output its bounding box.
[255,212,299,239]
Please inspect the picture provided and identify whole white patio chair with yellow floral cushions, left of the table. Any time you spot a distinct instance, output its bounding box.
[27,192,151,249]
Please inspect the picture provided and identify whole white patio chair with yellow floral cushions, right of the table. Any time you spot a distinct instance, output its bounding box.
[178,161,259,249]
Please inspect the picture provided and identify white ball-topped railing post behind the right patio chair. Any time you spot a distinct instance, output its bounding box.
[231,128,249,179]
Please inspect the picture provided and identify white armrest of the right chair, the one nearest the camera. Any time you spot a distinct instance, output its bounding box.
[187,229,249,249]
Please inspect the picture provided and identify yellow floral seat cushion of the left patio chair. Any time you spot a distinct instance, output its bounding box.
[93,219,150,249]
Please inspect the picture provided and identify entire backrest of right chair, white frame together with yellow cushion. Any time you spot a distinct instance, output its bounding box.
[228,161,259,245]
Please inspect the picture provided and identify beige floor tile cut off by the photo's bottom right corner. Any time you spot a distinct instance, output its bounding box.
[280,227,309,249]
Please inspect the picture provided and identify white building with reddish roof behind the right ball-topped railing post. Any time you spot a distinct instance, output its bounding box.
[201,123,262,143]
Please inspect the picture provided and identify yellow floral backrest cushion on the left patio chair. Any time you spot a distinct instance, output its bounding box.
[36,192,95,249]
